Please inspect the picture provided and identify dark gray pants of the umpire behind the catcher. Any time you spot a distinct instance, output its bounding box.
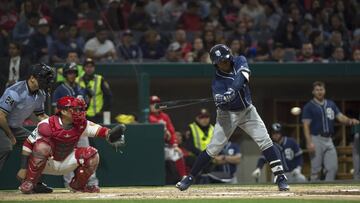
[0,128,29,172]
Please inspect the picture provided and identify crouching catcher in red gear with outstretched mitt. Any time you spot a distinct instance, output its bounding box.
[18,96,125,194]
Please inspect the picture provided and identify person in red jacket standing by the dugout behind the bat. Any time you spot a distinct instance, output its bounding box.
[149,95,187,184]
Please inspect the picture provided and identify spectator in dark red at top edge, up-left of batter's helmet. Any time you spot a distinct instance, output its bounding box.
[177,0,203,32]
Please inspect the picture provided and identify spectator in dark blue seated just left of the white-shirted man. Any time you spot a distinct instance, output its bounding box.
[49,25,81,63]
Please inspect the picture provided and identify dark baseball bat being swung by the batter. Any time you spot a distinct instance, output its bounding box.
[155,97,214,110]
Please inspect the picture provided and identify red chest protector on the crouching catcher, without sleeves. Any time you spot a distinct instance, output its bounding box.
[49,116,87,161]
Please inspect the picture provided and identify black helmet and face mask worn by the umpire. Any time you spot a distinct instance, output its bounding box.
[31,63,55,91]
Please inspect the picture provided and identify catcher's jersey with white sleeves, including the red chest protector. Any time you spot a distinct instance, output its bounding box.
[23,115,104,161]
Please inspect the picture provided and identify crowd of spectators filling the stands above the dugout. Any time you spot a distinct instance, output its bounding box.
[0,0,360,64]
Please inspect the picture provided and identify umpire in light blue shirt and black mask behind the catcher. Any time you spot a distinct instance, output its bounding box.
[0,64,55,192]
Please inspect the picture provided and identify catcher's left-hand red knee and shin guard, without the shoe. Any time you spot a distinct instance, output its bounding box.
[25,139,52,184]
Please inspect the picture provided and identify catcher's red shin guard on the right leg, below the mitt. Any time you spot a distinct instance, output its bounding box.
[69,147,100,192]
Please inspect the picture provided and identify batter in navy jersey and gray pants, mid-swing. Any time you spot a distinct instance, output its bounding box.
[176,44,289,191]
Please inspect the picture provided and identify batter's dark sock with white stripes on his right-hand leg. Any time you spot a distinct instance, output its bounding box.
[263,145,284,176]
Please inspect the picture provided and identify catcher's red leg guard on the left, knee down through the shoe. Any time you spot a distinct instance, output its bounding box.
[20,140,51,194]
